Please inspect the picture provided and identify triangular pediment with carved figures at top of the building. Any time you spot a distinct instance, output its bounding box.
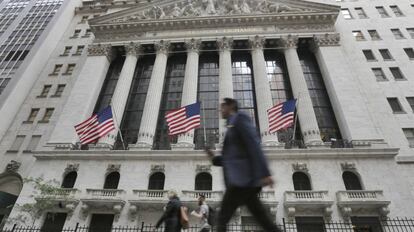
[90,0,339,25]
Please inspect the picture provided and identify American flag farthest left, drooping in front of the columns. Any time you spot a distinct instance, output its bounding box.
[75,106,115,145]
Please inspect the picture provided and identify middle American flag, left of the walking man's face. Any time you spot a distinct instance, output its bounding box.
[165,102,201,135]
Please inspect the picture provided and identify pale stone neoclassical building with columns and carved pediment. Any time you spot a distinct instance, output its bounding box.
[0,0,414,232]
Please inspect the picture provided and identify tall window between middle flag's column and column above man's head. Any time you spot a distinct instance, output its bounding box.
[195,53,219,149]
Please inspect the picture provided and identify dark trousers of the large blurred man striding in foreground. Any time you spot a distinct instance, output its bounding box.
[217,187,281,232]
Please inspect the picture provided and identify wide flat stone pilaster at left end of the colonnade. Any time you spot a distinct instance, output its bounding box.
[48,44,114,149]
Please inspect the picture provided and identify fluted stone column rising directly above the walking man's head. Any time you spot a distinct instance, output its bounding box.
[217,37,234,144]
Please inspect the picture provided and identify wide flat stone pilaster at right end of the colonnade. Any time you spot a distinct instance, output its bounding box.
[311,33,383,143]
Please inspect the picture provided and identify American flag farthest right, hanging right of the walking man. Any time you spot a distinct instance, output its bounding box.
[267,100,296,133]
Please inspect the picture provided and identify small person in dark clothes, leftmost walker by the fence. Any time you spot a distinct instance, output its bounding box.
[155,190,182,232]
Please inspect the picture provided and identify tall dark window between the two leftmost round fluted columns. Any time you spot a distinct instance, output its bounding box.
[118,55,155,144]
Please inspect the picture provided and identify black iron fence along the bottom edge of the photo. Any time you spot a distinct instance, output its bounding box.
[0,218,414,232]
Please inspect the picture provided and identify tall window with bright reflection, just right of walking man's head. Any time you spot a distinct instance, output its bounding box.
[232,52,259,128]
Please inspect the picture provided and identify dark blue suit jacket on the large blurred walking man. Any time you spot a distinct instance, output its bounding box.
[213,113,271,187]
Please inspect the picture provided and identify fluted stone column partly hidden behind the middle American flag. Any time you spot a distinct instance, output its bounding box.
[173,39,201,149]
